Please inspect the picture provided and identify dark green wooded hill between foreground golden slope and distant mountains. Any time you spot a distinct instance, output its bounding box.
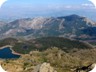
[0,37,93,54]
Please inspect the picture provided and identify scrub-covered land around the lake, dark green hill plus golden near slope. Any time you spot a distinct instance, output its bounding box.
[0,37,96,72]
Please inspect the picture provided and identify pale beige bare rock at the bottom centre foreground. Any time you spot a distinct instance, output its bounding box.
[33,63,57,72]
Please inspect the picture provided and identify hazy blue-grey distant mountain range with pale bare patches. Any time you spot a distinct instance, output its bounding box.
[0,14,96,38]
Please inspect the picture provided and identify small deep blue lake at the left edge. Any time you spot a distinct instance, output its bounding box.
[0,47,20,59]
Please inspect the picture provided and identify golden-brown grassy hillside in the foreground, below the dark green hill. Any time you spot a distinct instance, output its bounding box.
[0,47,96,72]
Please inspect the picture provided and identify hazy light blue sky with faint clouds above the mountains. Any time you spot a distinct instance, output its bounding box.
[0,0,96,19]
